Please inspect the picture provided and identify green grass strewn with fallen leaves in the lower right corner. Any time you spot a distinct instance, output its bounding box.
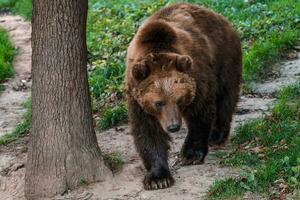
[208,82,300,199]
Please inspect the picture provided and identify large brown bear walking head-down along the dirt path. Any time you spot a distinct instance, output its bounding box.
[125,3,242,189]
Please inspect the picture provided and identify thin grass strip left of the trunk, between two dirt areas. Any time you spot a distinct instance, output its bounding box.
[0,99,31,145]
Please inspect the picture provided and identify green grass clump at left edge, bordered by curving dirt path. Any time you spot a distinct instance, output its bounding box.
[0,28,15,82]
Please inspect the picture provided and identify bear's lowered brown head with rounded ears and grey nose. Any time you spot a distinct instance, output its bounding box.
[132,53,196,132]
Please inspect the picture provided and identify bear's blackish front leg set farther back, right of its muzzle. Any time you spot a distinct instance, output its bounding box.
[181,116,212,165]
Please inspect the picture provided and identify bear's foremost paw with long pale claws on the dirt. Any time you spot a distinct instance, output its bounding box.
[143,170,174,190]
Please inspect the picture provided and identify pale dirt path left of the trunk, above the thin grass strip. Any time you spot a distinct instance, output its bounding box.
[0,15,31,137]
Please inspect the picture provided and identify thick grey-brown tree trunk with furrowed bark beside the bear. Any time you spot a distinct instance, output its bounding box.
[25,0,111,199]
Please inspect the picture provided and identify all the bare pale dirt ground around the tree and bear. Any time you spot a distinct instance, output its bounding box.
[0,16,300,200]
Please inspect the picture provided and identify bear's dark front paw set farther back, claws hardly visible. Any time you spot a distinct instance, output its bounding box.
[181,148,207,165]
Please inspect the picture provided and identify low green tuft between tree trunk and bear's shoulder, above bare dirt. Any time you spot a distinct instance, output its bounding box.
[98,104,127,130]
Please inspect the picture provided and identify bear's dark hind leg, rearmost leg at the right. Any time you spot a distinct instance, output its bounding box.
[209,92,238,146]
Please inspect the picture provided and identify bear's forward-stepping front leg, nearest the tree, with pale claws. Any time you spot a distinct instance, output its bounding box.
[128,99,174,190]
